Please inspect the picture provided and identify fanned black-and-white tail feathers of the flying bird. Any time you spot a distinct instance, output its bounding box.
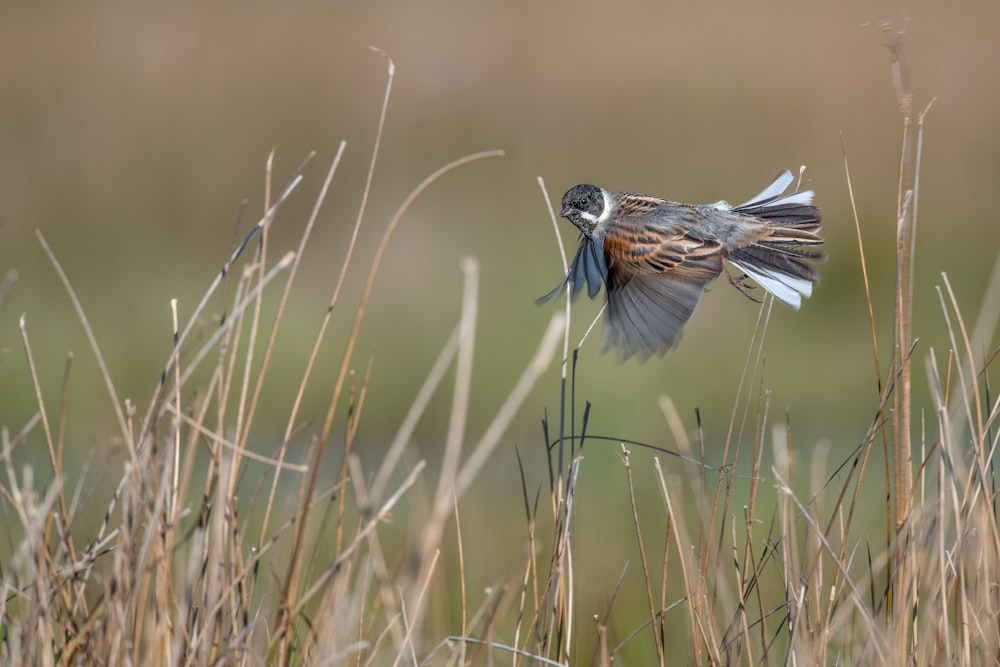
[727,171,826,310]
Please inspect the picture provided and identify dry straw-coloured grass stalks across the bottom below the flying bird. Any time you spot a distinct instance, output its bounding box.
[0,26,1000,665]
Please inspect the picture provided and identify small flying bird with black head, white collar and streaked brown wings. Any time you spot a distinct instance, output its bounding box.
[538,170,826,361]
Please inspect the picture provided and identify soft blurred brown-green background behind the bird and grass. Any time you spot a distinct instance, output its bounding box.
[0,0,1000,656]
